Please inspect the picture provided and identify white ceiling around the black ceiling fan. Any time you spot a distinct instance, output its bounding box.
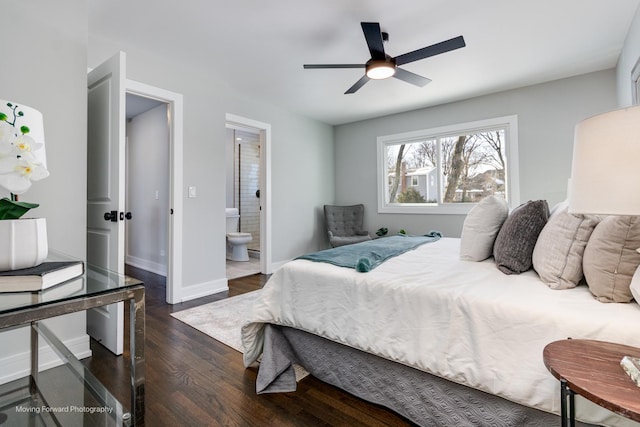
[89,0,640,124]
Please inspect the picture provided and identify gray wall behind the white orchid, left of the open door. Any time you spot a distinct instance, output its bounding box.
[0,0,90,381]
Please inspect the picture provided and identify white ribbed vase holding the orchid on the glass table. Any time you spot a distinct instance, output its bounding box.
[0,218,49,271]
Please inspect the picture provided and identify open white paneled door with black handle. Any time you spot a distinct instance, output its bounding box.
[87,52,126,355]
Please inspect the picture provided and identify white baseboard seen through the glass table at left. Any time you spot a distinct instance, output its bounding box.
[0,334,91,384]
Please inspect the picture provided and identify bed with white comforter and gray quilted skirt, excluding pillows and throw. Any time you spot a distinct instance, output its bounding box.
[242,200,640,426]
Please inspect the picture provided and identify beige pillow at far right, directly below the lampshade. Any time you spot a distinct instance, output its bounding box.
[582,215,640,302]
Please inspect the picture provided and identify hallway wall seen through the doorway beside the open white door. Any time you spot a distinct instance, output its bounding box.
[125,104,170,276]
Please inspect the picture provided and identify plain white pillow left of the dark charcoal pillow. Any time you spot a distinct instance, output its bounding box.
[460,196,509,261]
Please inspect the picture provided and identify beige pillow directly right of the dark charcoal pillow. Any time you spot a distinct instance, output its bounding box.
[533,206,600,289]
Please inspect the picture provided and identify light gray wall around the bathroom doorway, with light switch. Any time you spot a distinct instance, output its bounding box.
[89,38,334,296]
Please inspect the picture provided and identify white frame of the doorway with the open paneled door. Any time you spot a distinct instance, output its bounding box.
[125,79,183,304]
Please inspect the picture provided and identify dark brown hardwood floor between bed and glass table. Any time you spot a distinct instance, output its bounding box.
[83,267,413,427]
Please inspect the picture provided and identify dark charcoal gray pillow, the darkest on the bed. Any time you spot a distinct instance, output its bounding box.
[493,200,549,274]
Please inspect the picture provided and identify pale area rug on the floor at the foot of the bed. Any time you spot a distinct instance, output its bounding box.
[171,290,309,381]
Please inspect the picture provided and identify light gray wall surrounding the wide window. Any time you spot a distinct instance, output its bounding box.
[335,70,616,237]
